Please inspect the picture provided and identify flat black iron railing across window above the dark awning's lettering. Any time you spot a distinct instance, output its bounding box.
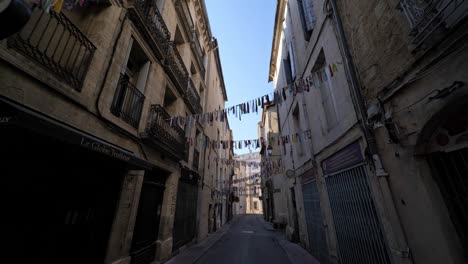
[111,74,145,128]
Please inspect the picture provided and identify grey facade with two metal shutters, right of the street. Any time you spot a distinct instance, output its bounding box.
[265,0,411,263]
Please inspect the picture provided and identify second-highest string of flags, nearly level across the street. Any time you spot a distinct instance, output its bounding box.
[185,130,311,150]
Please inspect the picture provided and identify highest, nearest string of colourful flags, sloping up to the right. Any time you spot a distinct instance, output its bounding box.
[168,62,342,126]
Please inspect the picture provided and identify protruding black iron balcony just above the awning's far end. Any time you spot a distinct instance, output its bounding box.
[142,105,185,160]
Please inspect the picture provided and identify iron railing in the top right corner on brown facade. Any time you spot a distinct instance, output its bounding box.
[399,0,468,48]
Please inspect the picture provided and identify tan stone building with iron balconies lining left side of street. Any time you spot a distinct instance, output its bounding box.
[0,0,232,264]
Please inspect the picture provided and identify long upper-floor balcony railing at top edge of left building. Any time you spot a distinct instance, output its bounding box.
[130,0,171,56]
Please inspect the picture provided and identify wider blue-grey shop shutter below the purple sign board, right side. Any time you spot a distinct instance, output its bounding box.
[326,165,391,264]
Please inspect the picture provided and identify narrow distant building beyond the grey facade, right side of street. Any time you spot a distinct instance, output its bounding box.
[258,102,288,227]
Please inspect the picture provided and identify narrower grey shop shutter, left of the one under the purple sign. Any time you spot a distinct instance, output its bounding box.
[302,180,329,264]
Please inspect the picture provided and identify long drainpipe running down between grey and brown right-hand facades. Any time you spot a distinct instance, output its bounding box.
[329,0,412,263]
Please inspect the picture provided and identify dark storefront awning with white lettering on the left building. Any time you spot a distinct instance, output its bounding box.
[0,97,153,169]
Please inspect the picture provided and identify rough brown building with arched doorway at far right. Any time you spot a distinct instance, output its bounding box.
[337,0,468,263]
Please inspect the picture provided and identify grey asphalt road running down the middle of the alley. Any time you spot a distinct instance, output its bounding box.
[196,215,290,264]
